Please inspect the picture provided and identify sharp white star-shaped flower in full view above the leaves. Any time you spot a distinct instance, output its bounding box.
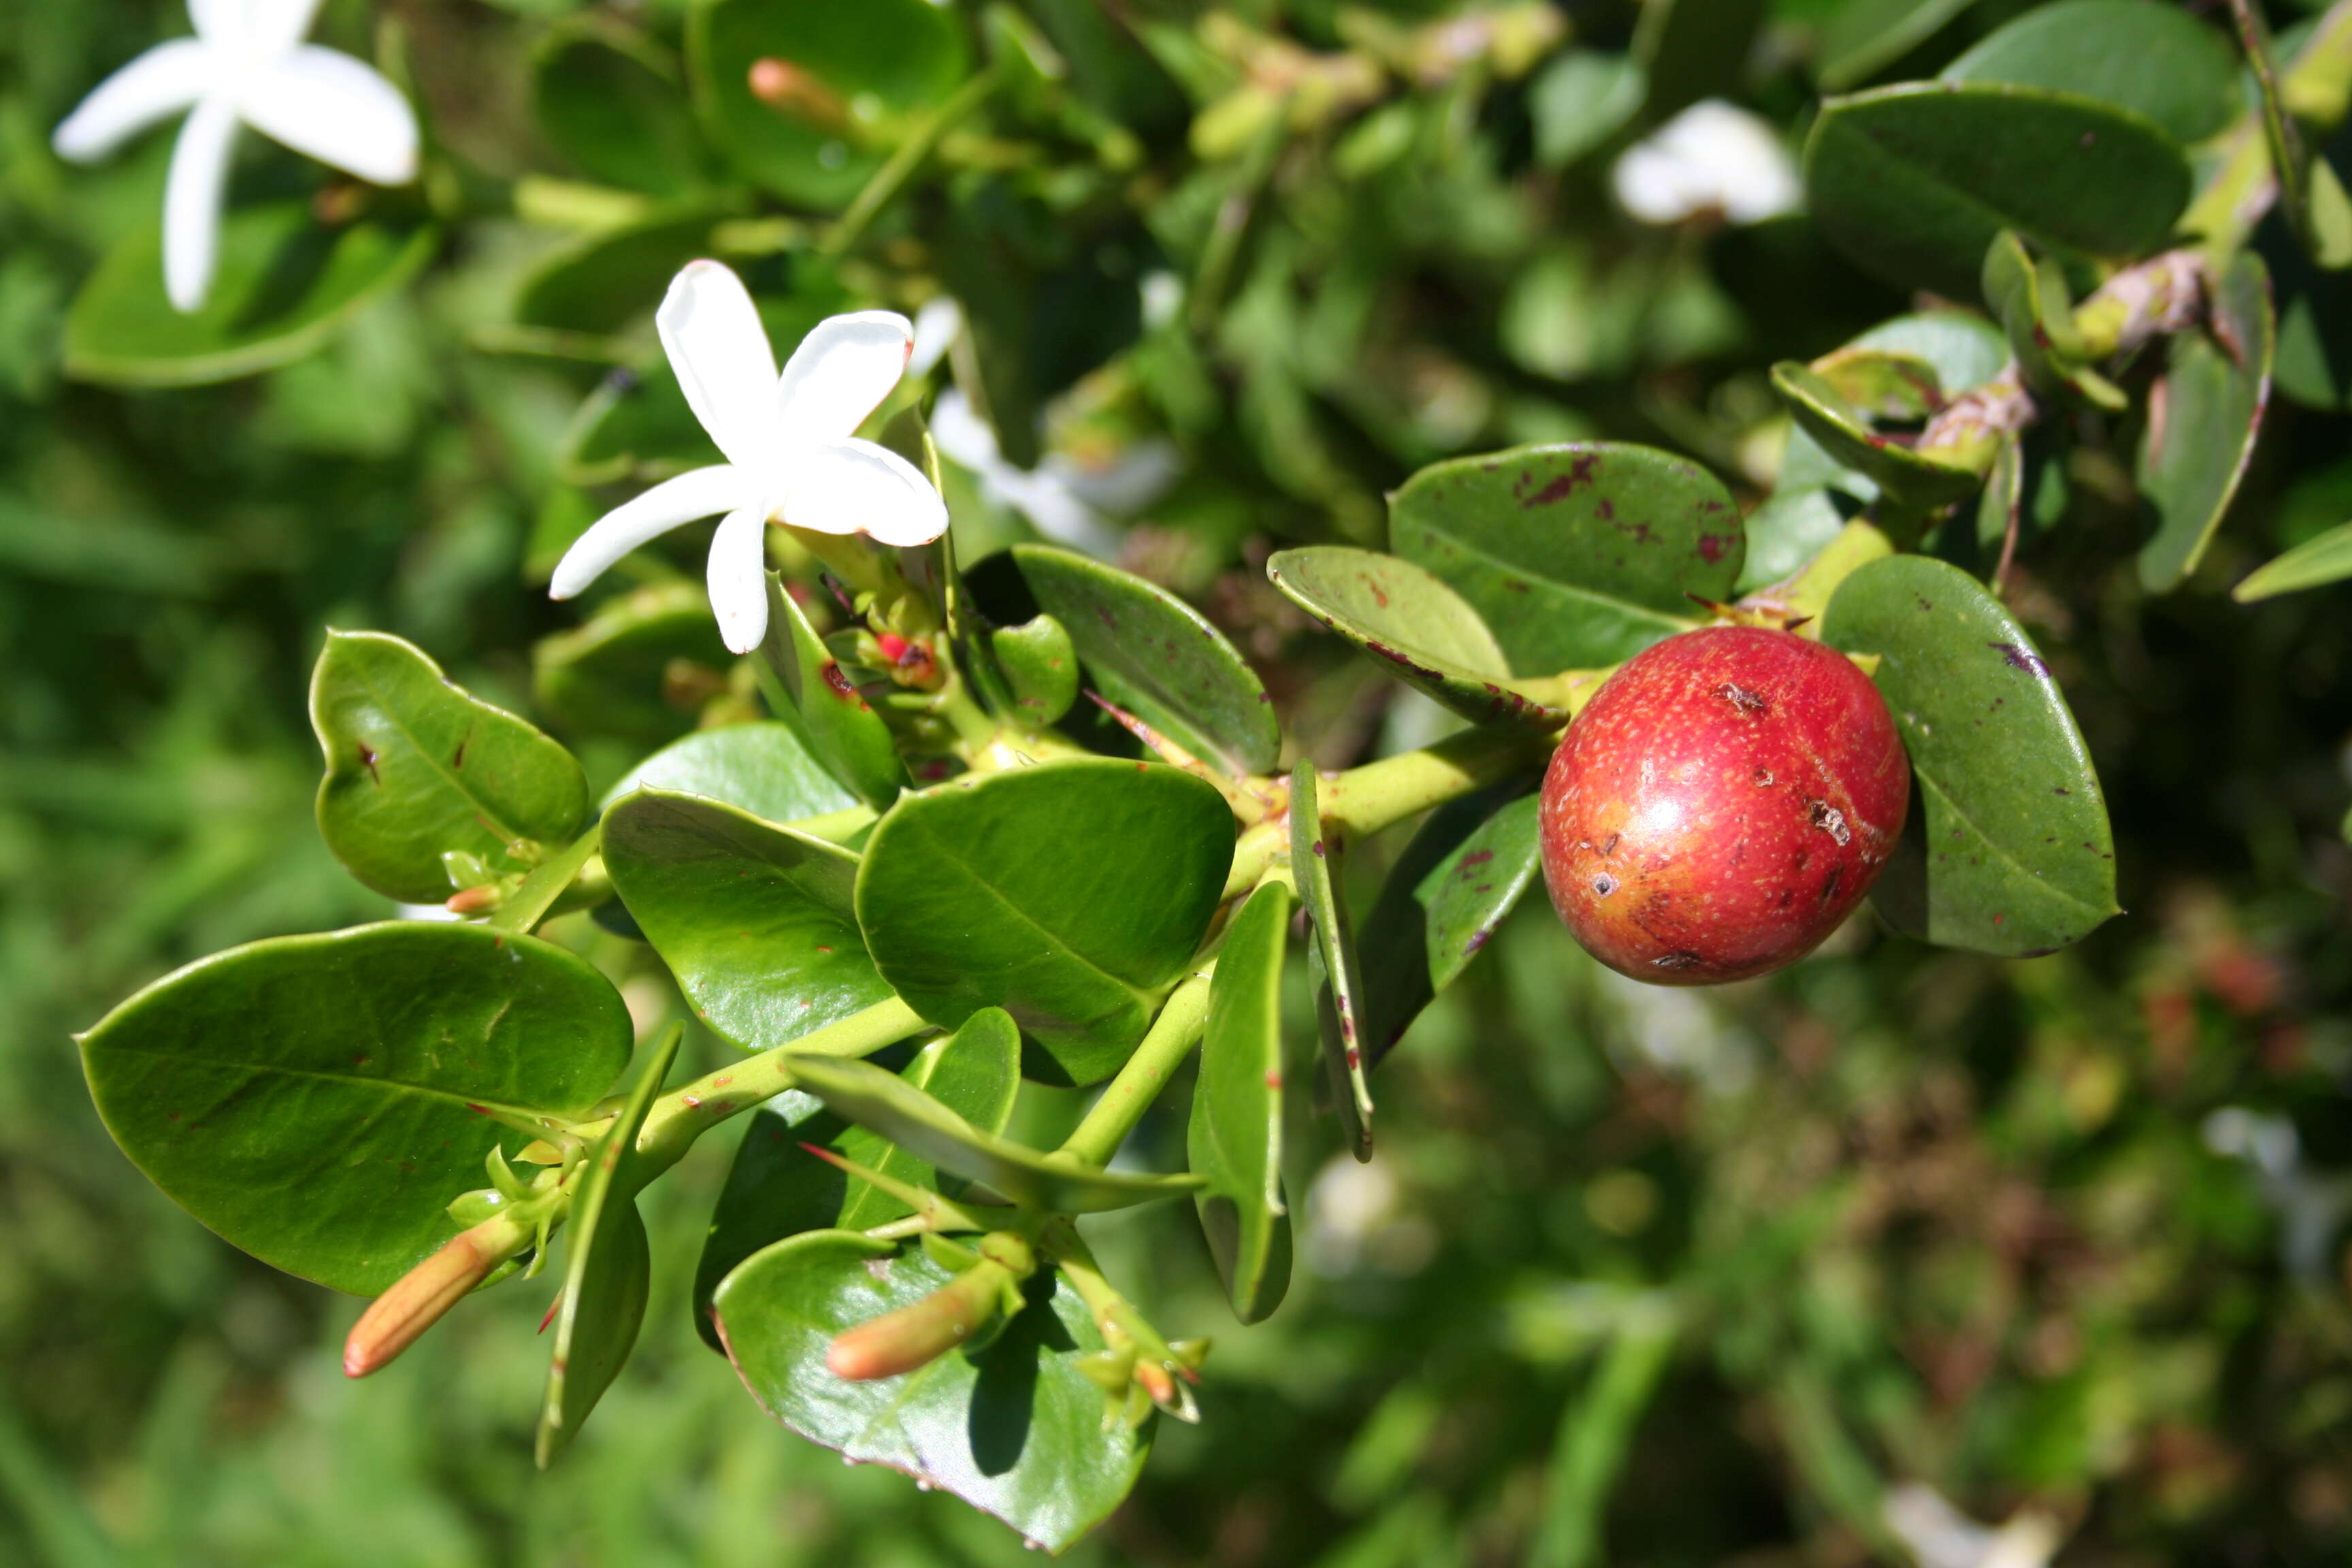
[548,261,948,653]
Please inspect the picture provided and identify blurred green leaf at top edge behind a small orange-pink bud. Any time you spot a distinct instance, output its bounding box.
[687,0,966,212]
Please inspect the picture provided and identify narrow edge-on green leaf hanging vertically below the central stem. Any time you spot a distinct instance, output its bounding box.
[1186,881,1296,1324]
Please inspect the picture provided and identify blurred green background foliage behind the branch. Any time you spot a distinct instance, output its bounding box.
[0,0,2352,1568]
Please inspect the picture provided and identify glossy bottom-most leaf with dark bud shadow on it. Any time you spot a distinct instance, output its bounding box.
[717,1232,1150,1552]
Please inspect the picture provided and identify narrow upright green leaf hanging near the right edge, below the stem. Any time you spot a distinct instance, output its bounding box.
[2138,252,2276,592]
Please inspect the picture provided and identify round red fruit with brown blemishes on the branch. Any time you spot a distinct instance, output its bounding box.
[1543,625,1910,985]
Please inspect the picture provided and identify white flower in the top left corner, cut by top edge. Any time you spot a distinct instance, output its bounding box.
[54,0,416,310]
